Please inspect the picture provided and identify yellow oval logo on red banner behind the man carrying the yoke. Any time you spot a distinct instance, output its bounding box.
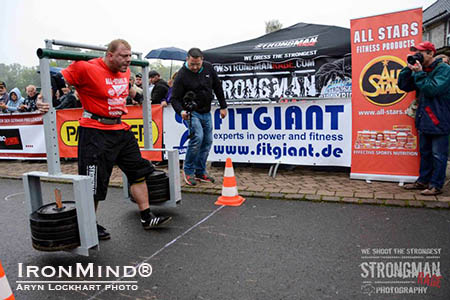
[60,119,159,148]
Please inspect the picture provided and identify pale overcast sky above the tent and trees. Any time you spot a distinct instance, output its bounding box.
[0,0,435,66]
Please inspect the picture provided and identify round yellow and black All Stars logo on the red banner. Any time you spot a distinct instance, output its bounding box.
[359,56,406,106]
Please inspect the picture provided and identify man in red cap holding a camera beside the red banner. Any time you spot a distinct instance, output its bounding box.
[398,42,450,196]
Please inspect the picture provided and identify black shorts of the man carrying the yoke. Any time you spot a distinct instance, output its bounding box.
[78,126,154,201]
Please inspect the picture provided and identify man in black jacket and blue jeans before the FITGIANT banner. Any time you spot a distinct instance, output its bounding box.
[171,48,227,185]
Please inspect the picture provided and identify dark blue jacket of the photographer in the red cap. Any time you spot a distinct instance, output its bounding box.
[398,59,450,135]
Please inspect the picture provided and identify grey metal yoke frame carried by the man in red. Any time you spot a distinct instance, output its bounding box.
[22,40,181,256]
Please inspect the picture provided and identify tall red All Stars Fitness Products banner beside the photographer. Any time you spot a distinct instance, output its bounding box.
[350,8,422,182]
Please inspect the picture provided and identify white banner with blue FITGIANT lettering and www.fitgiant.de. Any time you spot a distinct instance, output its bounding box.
[164,99,351,166]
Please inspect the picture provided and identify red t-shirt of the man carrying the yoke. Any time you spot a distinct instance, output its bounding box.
[61,57,130,130]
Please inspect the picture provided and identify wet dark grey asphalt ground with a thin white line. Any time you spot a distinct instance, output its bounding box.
[0,179,450,300]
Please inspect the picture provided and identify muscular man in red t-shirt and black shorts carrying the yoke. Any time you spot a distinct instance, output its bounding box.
[37,39,171,239]
